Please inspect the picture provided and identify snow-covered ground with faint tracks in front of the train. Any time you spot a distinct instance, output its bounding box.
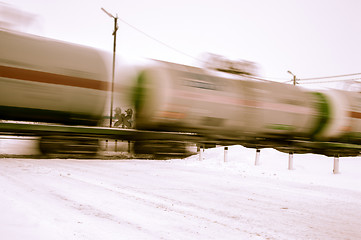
[0,139,361,240]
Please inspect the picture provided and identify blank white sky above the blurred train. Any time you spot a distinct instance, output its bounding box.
[3,0,361,88]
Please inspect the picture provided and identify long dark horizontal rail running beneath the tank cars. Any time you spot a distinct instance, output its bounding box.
[0,122,361,156]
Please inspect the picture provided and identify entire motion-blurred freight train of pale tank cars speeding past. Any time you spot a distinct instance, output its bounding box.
[0,30,361,156]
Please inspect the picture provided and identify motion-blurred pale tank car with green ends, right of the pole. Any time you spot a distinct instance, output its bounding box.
[133,62,320,141]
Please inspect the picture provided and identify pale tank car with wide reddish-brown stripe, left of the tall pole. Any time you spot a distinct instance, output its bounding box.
[0,30,108,125]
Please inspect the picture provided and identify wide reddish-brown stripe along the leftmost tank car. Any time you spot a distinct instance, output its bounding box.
[0,66,109,91]
